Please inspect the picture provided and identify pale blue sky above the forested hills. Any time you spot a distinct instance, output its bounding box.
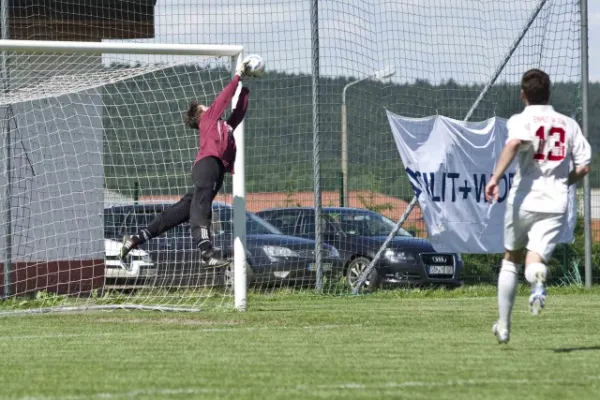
[105,0,600,83]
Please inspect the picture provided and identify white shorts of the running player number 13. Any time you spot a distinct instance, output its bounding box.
[504,204,566,262]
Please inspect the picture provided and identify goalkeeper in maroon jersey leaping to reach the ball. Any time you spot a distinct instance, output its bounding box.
[119,60,250,267]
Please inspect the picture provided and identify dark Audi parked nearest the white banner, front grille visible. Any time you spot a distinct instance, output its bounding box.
[256,207,463,288]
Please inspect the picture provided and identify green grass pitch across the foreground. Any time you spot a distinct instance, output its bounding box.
[0,286,600,400]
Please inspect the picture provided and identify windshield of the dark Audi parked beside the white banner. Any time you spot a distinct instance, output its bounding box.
[326,210,411,237]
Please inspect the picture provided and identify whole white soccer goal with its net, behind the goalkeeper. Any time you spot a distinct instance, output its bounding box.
[0,40,247,312]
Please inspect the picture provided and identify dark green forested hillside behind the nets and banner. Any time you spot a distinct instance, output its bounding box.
[104,66,600,200]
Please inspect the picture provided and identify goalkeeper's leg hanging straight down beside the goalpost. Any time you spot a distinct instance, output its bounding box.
[190,157,229,267]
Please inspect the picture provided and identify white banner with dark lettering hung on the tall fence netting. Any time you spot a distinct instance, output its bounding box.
[387,111,577,254]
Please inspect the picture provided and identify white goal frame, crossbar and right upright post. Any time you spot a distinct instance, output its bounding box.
[0,39,247,311]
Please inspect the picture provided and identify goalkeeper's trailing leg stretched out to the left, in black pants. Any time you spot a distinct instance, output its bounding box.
[119,191,193,262]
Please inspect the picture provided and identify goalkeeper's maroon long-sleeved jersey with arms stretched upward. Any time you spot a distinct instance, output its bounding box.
[194,75,250,174]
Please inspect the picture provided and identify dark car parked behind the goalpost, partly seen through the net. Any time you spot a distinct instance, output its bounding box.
[104,202,342,287]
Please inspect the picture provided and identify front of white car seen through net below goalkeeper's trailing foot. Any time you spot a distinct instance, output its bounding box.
[104,239,156,279]
